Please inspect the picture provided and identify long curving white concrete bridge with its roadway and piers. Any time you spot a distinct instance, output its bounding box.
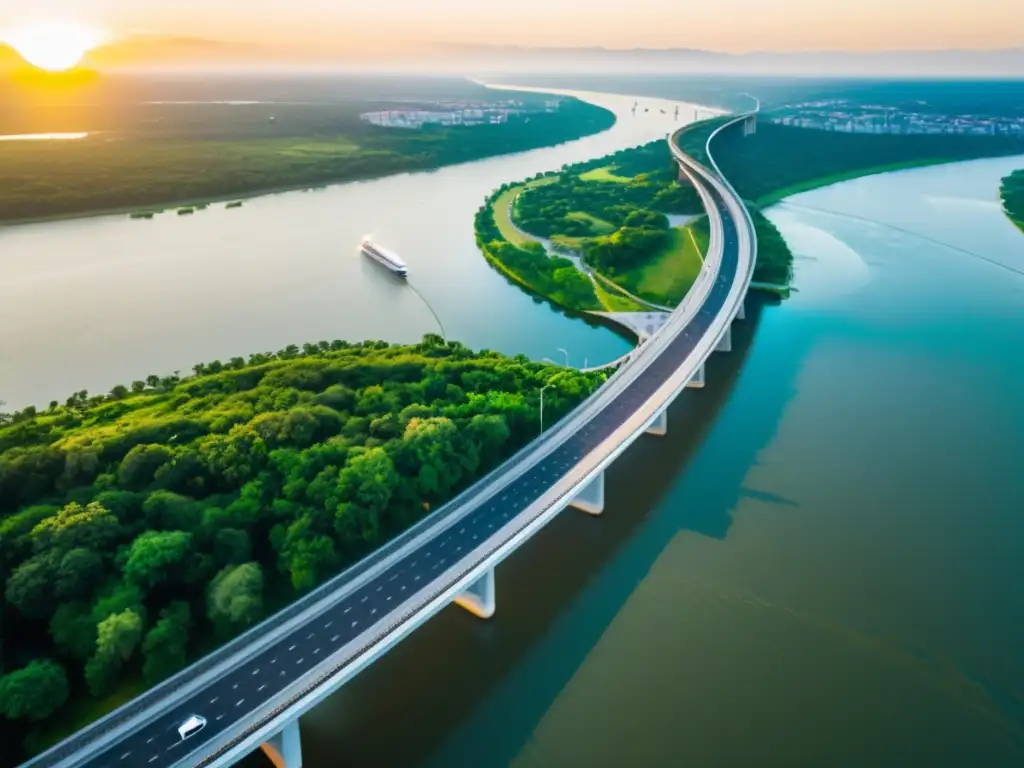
[27,102,757,768]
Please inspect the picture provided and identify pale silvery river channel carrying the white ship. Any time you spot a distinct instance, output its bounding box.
[0,94,695,409]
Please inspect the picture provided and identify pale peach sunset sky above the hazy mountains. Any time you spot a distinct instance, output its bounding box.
[0,0,1024,52]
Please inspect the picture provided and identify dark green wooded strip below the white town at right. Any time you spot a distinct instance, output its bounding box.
[714,118,1024,206]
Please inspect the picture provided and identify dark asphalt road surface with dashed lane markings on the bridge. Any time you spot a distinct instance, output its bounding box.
[56,185,739,768]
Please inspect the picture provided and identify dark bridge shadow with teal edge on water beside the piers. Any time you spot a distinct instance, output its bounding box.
[245,294,802,768]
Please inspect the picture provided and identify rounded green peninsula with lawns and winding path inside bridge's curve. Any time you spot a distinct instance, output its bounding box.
[476,140,702,311]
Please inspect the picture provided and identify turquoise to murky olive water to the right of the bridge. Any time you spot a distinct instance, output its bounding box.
[268,159,1024,768]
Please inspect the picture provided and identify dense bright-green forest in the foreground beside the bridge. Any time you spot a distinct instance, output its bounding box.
[0,335,605,762]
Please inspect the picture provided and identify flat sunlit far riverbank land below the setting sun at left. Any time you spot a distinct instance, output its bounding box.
[0,78,614,221]
